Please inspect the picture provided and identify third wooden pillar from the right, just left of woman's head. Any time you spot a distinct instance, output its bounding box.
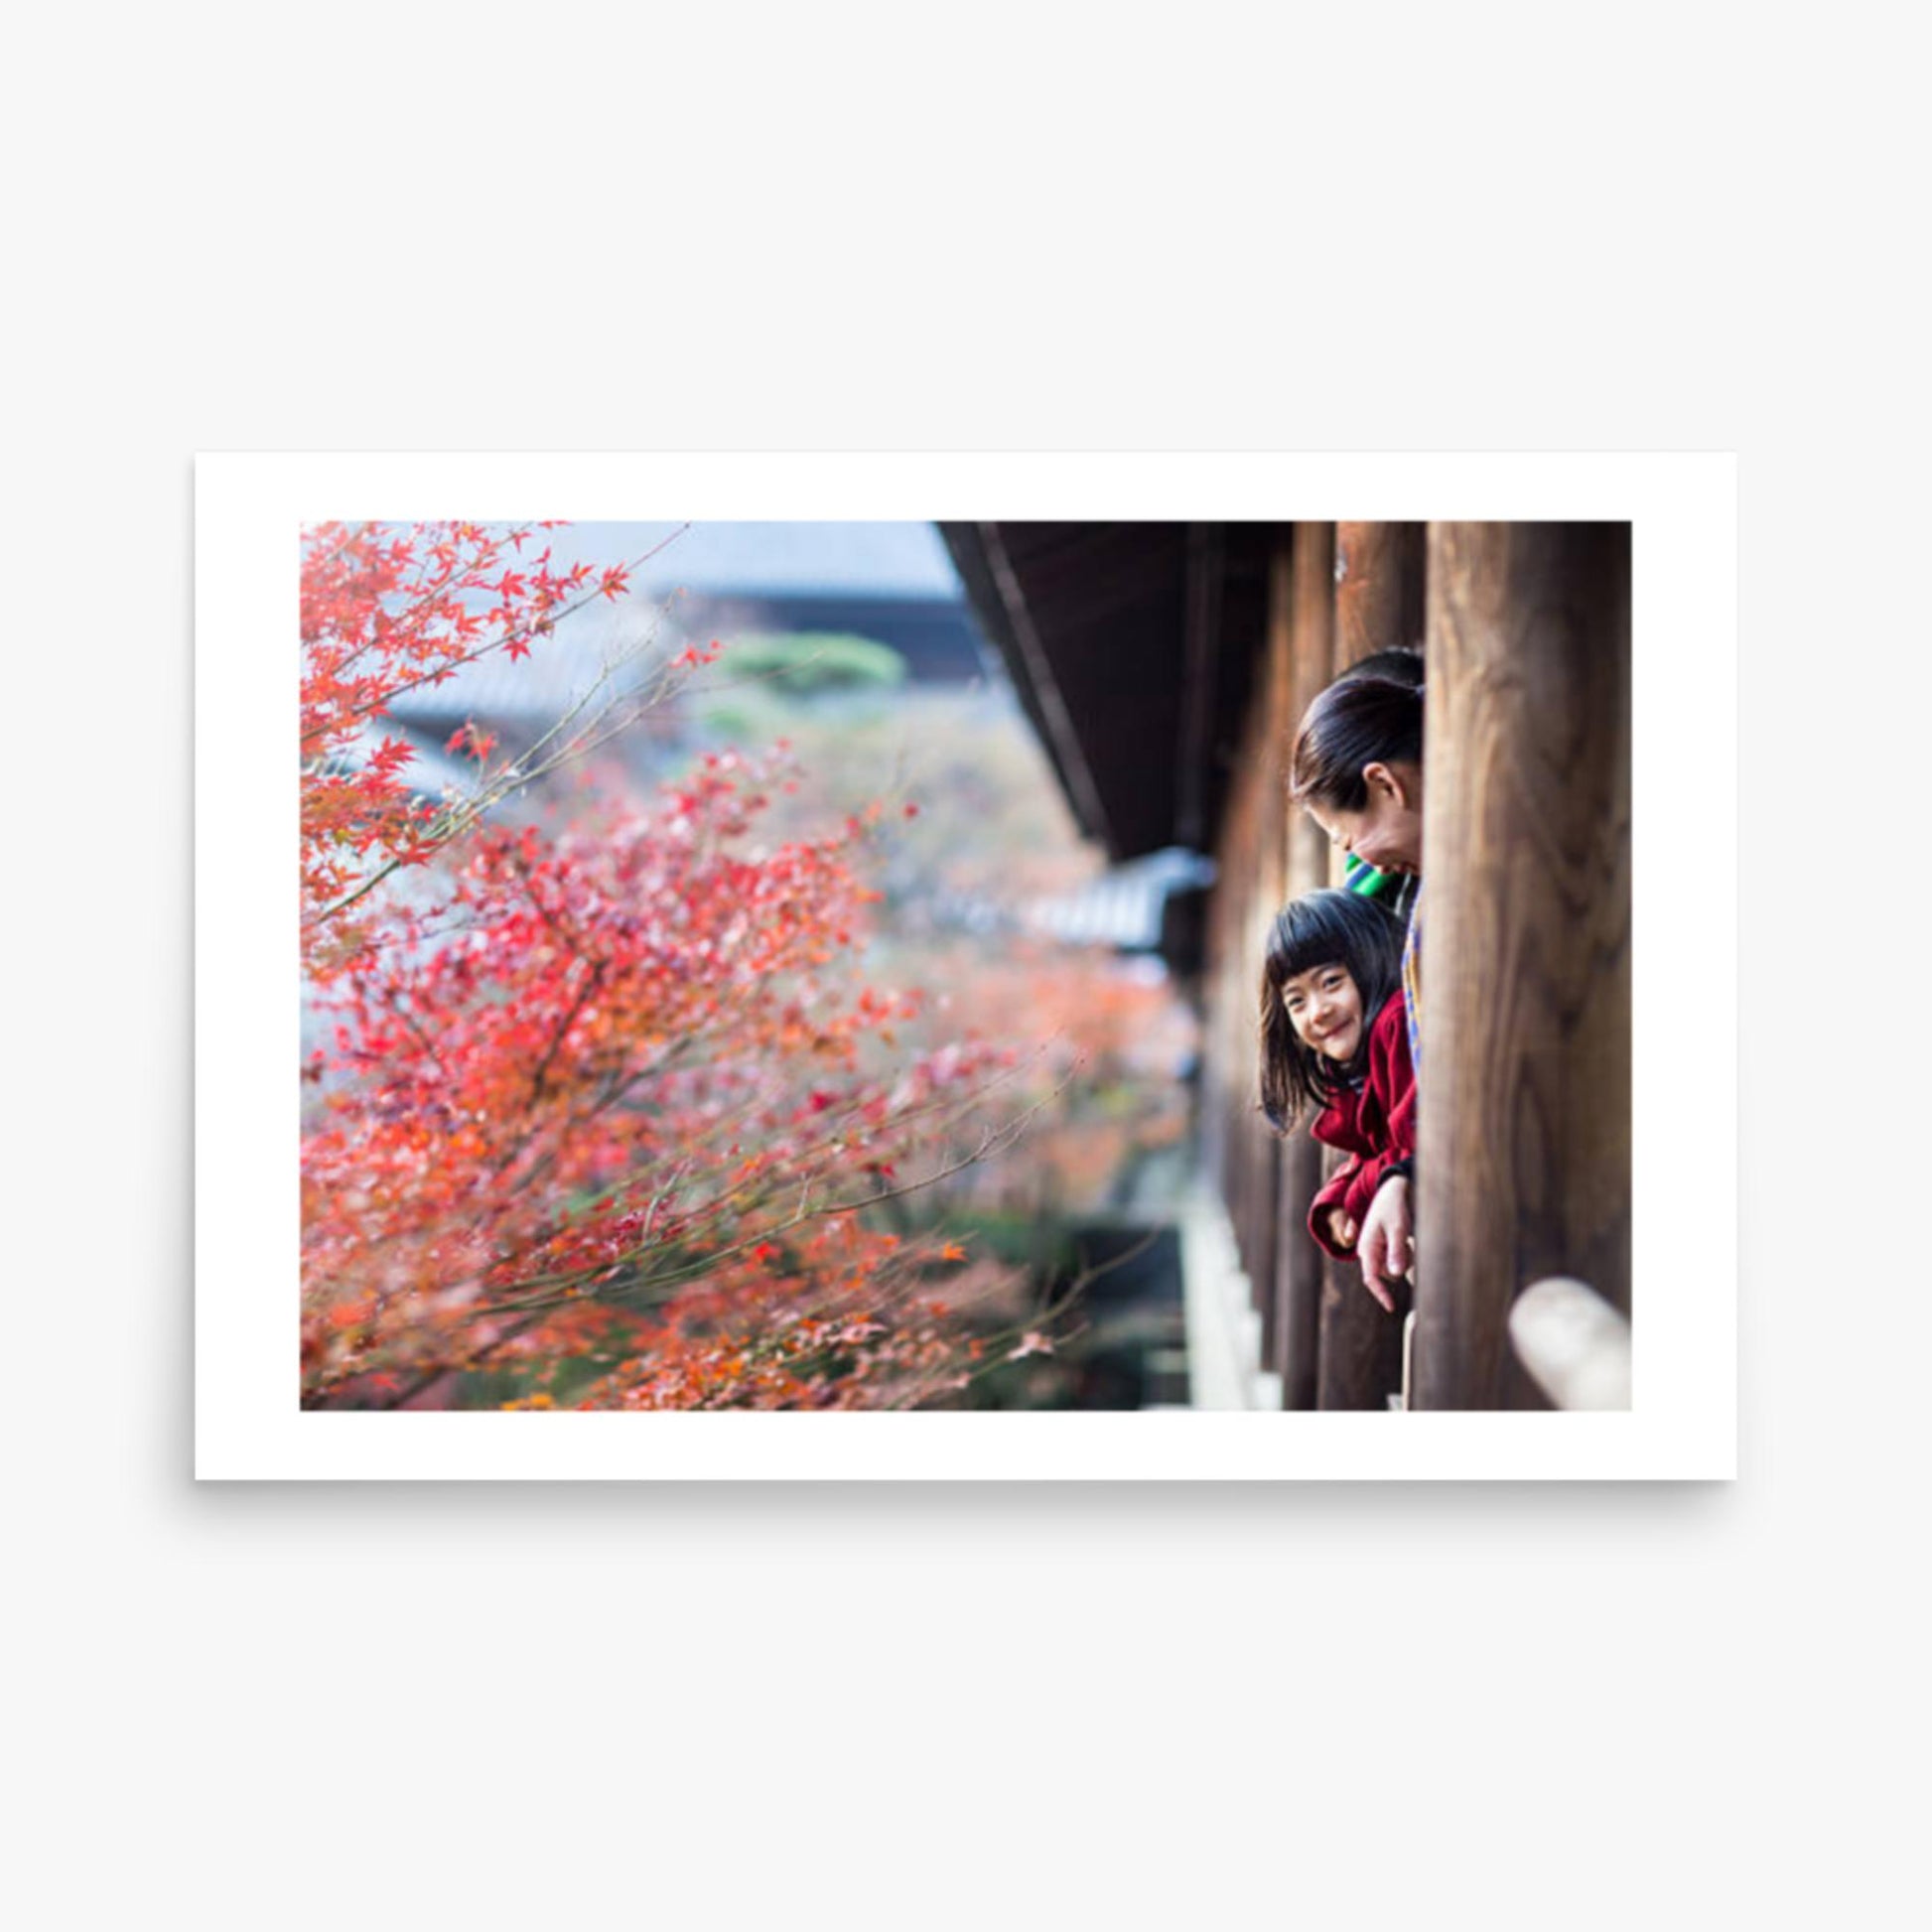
[1275,523,1335,1409]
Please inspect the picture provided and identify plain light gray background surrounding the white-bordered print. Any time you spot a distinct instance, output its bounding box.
[0,0,1893,1926]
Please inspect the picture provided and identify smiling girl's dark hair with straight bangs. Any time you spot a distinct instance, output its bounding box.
[1262,887,1403,1134]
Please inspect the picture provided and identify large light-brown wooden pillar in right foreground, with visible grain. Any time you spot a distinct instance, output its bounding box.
[1414,523,1630,1409]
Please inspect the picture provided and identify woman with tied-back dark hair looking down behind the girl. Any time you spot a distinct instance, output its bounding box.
[1289,672,1424,1308]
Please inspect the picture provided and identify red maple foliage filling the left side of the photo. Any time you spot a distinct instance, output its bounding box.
[302,523,1043,1409]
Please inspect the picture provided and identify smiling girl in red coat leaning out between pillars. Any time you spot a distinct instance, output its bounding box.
[1262,891,1416,1311]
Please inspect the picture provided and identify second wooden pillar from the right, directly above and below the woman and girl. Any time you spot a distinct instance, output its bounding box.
[1303,523,1426,1409]
